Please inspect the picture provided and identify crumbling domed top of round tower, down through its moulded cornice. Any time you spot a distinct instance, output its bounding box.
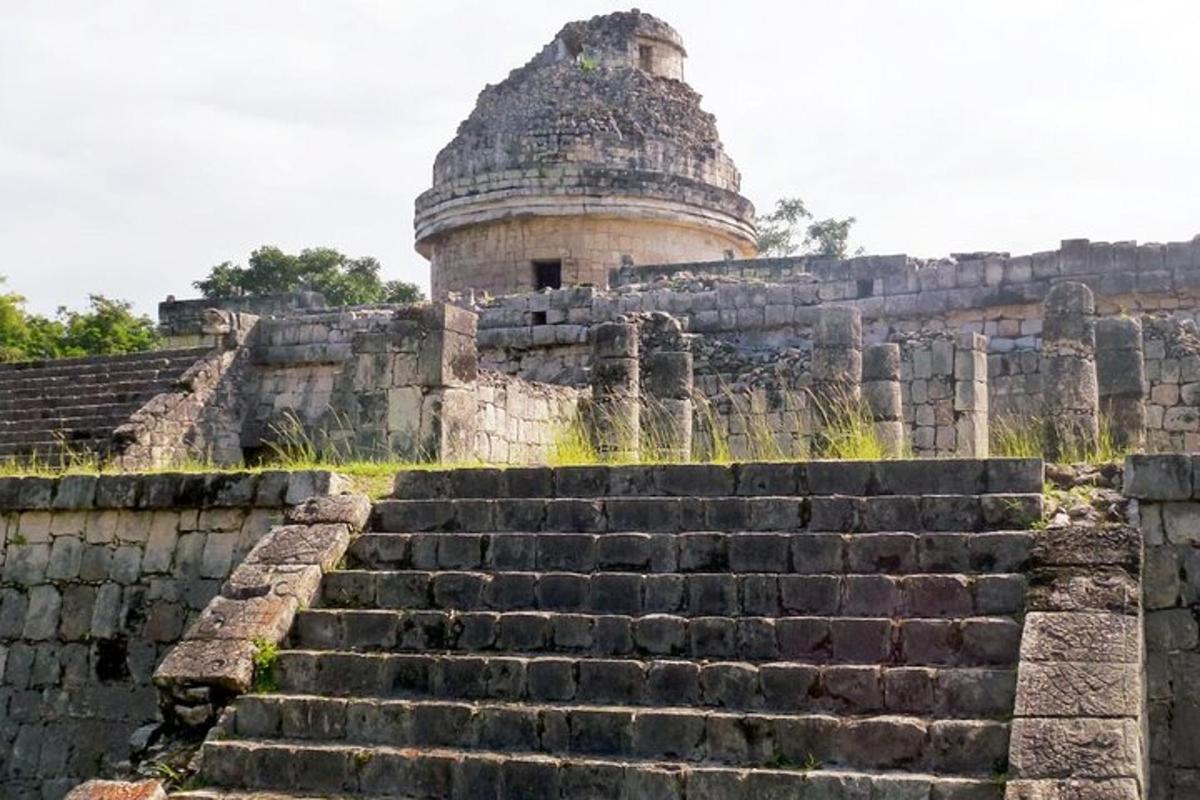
[415,10,754,260]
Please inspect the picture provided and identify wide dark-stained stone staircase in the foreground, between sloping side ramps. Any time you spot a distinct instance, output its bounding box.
[180,461,1042,800]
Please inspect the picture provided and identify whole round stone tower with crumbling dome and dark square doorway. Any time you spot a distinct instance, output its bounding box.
[415,10,755,297]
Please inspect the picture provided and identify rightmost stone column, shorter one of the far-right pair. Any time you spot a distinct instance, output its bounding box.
[1096,317,1146,450]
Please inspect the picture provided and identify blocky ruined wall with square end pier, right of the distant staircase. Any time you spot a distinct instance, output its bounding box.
[242,303,478,461]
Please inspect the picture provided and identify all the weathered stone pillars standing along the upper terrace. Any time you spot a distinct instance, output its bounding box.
[590,282,1146,459]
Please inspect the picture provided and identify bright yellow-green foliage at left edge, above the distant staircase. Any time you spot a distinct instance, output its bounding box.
[0,277,158,361]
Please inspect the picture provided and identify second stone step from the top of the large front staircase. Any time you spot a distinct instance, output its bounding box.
[371,493,1042,533]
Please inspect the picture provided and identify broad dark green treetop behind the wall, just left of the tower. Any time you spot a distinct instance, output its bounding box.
[192,246,424,306]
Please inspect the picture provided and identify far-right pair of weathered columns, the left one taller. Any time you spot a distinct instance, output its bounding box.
[1042,282,1146,459]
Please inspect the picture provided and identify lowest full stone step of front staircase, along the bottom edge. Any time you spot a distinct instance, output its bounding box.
[194,740,1004,800]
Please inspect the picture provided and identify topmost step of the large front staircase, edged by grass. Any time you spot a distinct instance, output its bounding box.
[394,458,1043,500]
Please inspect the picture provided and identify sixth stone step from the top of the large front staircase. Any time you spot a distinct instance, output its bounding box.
[275,650,1016,718]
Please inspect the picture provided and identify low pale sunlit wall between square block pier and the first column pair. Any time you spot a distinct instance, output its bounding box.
[475,372,586,464]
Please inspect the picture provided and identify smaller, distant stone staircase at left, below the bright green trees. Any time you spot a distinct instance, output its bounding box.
[0,348,208,465]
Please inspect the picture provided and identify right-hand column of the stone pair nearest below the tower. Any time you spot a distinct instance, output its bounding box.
[640,312,692,461]
